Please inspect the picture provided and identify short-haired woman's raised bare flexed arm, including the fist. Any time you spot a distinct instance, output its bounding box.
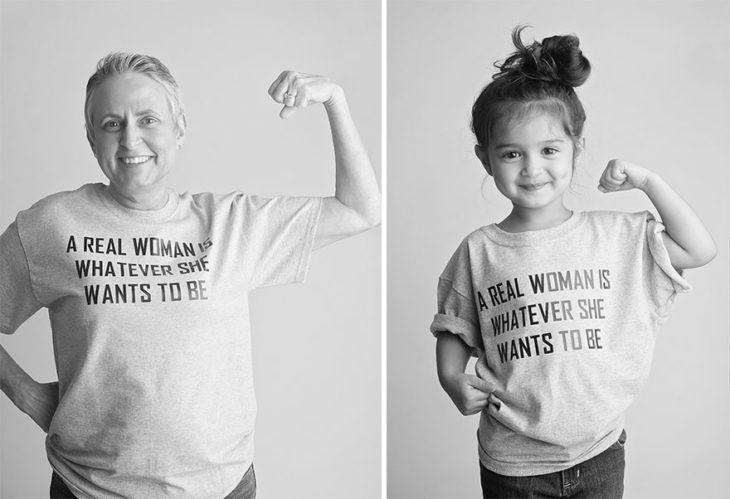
[269,71,380,248]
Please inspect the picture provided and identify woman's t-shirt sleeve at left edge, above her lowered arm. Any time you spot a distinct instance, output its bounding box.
[0,222,42,334]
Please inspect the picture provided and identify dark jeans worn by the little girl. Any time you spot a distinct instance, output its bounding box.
[479,431,626,499]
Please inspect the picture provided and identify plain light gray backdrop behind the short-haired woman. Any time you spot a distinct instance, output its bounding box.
[0,0,381,499]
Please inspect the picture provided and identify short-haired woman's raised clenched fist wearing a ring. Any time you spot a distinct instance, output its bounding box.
[269,71,345,118]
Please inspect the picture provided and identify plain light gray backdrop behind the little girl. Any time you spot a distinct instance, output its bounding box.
[387,0,730,499]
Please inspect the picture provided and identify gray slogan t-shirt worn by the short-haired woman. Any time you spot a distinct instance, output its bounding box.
[0,184,322,499]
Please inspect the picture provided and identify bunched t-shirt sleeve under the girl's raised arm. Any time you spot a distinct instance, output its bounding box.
[642,212,692,319]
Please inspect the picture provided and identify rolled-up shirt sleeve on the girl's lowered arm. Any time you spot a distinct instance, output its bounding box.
[430,243,484,356]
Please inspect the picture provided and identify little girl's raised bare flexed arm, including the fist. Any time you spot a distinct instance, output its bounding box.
[598,159,717,269]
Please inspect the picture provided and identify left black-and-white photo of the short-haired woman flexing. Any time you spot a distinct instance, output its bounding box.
[0,1,381,499]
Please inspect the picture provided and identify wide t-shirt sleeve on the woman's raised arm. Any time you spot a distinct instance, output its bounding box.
[240,196,322,289]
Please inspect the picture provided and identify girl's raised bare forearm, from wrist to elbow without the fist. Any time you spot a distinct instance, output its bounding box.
[640,173,717,268]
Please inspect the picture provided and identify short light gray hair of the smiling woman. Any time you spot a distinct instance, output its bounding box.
[84,52,187,140]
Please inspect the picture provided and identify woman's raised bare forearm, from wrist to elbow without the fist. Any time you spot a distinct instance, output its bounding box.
[325,88,380,230]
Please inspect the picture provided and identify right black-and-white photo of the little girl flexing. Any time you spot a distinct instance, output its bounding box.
[387,0,730,499]
